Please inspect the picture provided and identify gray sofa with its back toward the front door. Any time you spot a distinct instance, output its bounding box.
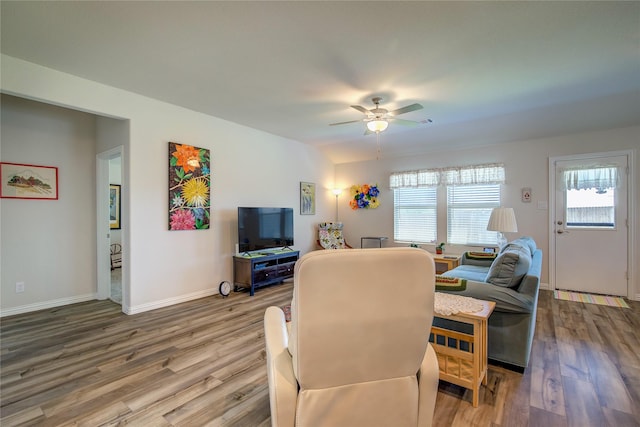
[434,237,542,370]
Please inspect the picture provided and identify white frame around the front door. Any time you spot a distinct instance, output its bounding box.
[548,150,636,300]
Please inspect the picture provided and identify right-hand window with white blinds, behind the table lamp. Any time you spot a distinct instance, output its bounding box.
[447,184,500,245]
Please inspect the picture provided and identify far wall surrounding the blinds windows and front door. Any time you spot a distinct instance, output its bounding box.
[336,127,640,298]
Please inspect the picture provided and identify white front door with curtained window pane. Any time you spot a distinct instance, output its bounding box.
[549,154,629,296]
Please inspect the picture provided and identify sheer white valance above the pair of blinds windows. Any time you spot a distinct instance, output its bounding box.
[389,163,505,190]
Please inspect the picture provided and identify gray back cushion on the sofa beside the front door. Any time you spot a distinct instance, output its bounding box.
[485,245,531,288]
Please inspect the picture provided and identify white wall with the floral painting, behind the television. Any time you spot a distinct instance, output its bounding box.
[1,55,334,314]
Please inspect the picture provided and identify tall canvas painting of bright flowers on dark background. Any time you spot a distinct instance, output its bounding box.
[169,142,211,230]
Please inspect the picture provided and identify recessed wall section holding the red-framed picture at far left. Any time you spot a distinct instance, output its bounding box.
[0,95,96,310]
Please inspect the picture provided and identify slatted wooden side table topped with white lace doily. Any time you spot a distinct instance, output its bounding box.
[429,300,496,408]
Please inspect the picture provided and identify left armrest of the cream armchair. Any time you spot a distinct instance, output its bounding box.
[264,307,298,426]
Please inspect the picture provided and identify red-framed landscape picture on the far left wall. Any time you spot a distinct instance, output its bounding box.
[0,162,58,200]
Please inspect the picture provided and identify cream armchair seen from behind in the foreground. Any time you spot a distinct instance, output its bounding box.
[264,248,438,427]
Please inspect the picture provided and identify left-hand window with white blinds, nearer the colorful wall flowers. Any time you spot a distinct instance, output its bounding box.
[393,187,438,243]
